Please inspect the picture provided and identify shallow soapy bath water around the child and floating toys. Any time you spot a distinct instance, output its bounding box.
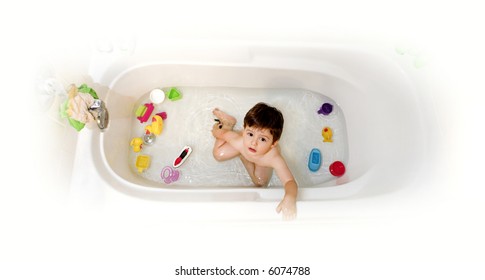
[127,87,348,188]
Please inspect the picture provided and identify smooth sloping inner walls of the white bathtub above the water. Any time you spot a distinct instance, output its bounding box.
[101,52,426,197]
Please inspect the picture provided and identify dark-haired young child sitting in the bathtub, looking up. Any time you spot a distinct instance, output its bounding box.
[212,103,298,220]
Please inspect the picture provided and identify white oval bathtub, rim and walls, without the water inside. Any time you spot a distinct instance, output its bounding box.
[71,42,439,211]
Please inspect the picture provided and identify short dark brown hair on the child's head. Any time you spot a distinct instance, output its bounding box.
[244,102,284,143]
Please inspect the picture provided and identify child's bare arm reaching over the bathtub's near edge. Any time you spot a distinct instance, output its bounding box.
[274,156,298,220]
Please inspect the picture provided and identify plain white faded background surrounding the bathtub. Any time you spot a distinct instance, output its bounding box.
[0,0,485,279]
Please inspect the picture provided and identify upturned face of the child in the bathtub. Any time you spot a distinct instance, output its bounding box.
[243,126,276,156]
